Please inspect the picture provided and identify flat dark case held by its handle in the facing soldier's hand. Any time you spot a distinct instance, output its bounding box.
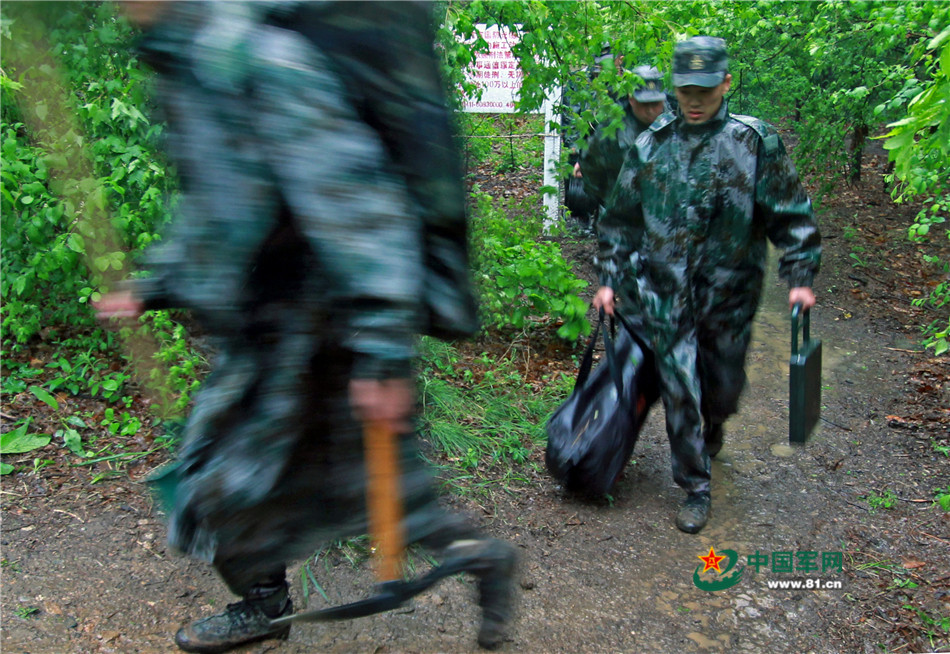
[788,304,821,443]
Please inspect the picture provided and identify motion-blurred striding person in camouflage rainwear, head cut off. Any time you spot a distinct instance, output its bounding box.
[98,2,516,652]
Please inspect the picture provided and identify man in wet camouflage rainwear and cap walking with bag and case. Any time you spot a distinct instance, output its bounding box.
[594,37,821,533]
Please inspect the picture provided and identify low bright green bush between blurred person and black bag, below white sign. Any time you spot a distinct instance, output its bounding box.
[472,189,590,340]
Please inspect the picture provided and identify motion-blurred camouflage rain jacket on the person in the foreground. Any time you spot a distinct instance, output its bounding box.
[133,2,477,376]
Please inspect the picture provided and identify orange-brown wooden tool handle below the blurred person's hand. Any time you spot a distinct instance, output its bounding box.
[363,421,405,581]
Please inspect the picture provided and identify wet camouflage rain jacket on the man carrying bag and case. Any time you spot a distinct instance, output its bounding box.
[598,101,821,352]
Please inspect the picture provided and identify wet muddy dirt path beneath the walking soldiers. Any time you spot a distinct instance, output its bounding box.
[2,247,944,653]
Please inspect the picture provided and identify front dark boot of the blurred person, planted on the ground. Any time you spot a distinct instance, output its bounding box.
[175,582,294,654]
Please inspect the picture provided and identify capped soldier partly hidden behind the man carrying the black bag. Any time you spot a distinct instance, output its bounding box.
[575,66,667,205]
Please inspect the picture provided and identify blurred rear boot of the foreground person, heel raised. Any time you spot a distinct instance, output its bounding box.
[445,538,518,649]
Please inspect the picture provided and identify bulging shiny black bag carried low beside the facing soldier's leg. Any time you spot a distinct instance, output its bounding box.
[545,312,659,495]
